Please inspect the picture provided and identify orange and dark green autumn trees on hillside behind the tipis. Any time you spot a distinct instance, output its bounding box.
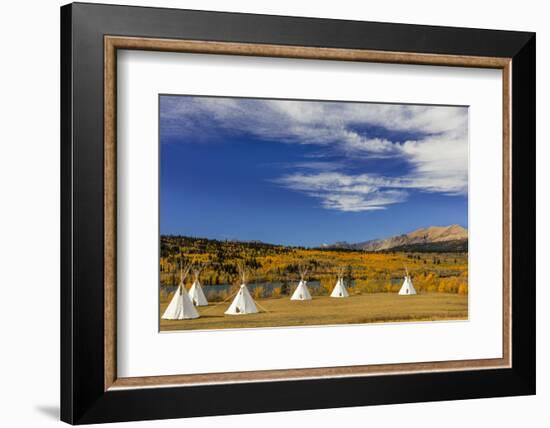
[160,236,468,301]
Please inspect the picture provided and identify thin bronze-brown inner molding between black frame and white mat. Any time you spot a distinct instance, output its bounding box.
[104,36,512,391]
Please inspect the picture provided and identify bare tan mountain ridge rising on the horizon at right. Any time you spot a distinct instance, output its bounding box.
[323,224,468,252]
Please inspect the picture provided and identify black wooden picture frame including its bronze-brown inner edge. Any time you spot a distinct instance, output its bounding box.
[61,4,535,424]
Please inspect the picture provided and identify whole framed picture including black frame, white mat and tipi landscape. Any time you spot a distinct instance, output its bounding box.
[61,3,535,424]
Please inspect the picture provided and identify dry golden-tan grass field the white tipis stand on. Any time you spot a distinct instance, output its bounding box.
[160,292,468,331]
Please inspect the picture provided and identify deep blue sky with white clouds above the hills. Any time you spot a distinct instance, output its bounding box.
[160,95,468,246]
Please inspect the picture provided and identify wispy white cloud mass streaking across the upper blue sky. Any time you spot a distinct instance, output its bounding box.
[161,97,468,211]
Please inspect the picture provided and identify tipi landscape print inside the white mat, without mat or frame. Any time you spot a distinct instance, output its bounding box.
[157,94,468,334]
